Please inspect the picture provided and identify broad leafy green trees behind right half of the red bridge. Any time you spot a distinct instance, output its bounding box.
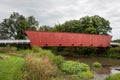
[54,15,112,35]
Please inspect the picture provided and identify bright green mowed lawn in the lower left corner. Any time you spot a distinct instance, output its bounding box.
[0,53,24,80]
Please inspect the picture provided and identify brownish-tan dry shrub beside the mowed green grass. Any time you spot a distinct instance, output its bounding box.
[25,54,57,80]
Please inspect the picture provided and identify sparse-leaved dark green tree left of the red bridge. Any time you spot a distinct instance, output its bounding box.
[0,12,38,39]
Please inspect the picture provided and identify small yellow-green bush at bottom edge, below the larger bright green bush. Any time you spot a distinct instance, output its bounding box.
[78,71,94,80]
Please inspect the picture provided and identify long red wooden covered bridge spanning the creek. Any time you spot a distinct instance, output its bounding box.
[25,31,112,47]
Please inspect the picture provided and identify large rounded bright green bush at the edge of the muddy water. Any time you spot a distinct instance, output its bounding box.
[60,61,90,74]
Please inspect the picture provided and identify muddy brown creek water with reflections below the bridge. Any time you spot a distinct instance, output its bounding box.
[66,57,120,80]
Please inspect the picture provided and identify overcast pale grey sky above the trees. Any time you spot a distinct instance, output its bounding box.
[0,0,120,39]
